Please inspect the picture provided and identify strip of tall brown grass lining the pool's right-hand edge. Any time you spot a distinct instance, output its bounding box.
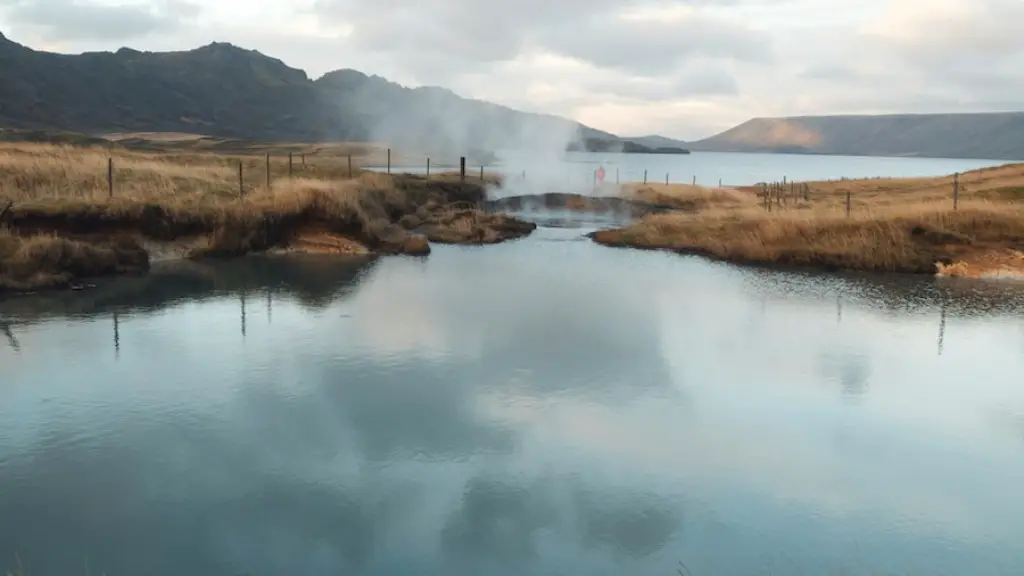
[593,201,1024,273]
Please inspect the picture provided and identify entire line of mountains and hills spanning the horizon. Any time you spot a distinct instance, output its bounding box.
[0,32,1024,160]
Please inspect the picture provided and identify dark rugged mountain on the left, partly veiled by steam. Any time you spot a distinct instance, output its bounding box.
[0,34,617,153]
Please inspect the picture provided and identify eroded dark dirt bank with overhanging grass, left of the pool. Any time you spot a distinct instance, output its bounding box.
[0,176,536,292]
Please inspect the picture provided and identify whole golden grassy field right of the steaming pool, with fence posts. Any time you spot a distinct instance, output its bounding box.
[592,164,1024,278]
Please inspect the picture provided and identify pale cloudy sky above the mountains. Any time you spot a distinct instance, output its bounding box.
[0,0,1024,139]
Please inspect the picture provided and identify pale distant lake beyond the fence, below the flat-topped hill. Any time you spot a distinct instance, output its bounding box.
[392,152,1010,193]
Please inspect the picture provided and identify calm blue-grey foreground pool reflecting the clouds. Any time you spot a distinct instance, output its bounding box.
[0,222,1024,576]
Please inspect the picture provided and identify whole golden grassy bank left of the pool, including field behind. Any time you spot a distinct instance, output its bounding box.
[0,142,532,290]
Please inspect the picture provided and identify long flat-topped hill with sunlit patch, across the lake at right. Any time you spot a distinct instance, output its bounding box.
[689,112,1024,160]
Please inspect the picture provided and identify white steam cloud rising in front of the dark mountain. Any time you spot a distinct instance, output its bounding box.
[317,71,617,198]
